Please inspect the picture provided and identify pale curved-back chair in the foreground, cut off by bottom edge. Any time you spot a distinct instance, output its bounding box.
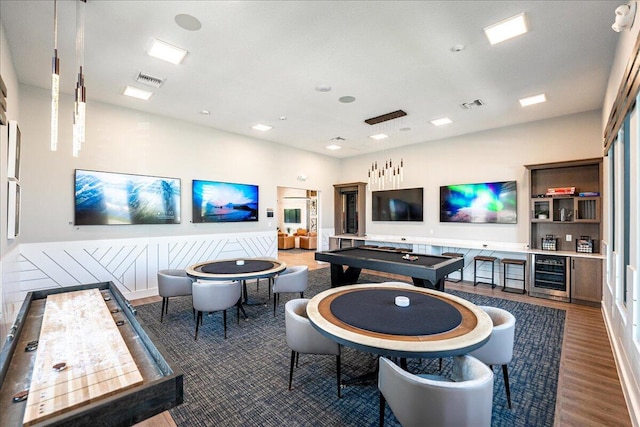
[378,355,493,427]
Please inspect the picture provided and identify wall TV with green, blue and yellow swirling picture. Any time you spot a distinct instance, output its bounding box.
[440,181,518,224]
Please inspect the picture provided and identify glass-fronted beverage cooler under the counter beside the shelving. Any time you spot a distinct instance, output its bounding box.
[529,254,571,302]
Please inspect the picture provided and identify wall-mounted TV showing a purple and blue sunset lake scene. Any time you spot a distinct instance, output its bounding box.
[192,179,258,223]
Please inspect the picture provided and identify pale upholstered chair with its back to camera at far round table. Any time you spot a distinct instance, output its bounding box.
[193,280,242,340]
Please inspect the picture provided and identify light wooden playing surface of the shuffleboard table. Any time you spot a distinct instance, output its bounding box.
[23,289,142,426]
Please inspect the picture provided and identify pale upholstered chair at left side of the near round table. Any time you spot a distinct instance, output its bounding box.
[284,298,341,397]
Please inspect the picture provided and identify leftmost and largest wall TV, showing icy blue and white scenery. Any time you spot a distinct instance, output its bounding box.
[74,169,180,225]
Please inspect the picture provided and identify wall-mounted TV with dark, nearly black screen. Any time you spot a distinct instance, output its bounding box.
[371,188,423,221]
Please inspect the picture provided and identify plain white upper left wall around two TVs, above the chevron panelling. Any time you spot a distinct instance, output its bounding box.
[20,86,340,243]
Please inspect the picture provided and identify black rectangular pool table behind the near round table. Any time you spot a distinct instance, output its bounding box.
[315,247,464,291]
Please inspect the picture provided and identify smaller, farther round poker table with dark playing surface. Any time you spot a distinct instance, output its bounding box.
[187,258,287,280]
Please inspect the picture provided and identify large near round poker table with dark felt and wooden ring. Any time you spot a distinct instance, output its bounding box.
[307,283,493,358]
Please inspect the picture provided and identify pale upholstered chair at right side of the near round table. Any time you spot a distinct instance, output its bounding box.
[470,306,516,409]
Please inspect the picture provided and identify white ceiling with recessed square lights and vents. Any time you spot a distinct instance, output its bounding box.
[0,0,621,157]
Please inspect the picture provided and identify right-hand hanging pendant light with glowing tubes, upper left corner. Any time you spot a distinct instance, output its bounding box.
[73,0,87,157]
